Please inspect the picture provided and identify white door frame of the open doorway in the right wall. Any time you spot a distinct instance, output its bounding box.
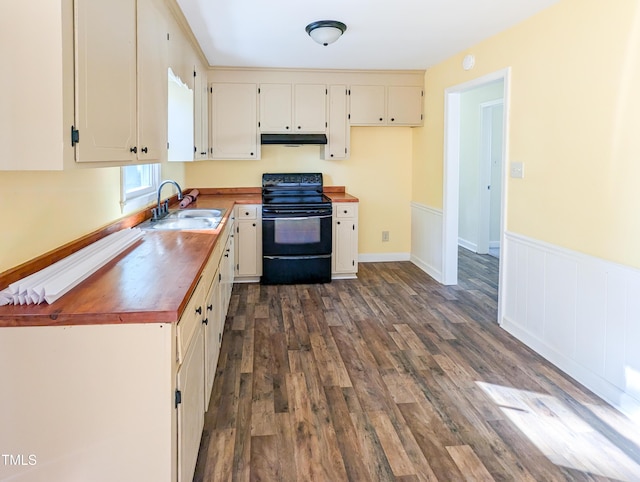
[442,67,511,320]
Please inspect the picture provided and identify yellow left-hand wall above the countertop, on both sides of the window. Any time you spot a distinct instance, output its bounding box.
[0,163,184,273]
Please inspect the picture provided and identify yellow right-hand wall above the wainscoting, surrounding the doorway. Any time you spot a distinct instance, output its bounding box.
[412,0,640,268]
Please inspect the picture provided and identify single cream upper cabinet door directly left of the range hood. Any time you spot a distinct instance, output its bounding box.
[210,83,260,159]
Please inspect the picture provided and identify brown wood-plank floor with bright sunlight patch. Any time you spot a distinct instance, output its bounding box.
[194,250,640,482]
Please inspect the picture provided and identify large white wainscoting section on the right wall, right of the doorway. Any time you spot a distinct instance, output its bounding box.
[501,233,640,422]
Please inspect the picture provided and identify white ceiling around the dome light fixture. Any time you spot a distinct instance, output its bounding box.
[177,0,559,70]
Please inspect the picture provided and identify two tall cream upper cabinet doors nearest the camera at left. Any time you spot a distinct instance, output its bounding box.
[74,0,167,163]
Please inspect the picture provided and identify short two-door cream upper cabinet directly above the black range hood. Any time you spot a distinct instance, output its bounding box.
[259,84,327,133]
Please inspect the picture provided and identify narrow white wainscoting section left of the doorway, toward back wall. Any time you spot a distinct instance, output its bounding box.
[411,202,443,283]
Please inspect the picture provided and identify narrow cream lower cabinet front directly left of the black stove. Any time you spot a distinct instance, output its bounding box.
[236,205,262,277]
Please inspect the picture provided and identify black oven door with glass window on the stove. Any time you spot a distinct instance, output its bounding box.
[262,206,332,256]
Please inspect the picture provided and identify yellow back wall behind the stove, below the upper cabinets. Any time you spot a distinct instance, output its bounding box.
[186,127,412,254]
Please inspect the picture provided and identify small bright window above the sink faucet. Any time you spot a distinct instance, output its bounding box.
[120,164,160,212]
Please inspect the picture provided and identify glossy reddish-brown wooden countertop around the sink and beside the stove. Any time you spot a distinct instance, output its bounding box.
[0,188,358,327]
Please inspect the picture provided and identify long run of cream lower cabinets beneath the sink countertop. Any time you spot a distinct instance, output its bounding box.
[0,217,234,482]
